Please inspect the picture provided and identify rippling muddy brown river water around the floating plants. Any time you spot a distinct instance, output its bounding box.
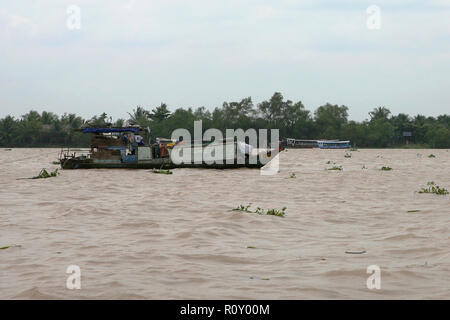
[0,149,450,299]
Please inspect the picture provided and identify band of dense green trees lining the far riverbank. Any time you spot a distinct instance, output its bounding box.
[0,92,450,148]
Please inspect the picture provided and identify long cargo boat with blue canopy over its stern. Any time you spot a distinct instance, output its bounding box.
[59,127,279,169]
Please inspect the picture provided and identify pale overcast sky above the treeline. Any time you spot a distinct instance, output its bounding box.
[0,0,450,120]
